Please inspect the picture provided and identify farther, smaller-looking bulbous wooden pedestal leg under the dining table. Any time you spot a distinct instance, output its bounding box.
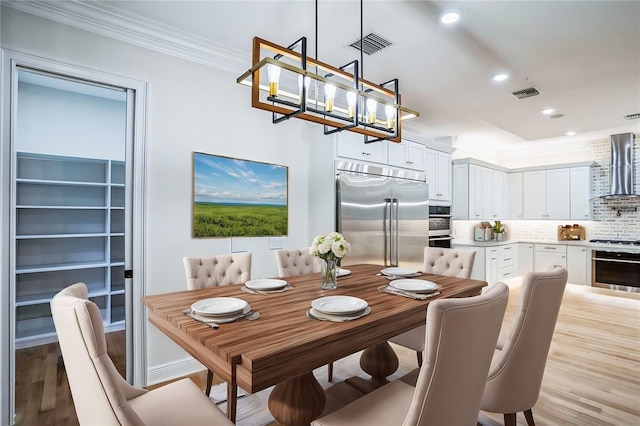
[345,342,400,393]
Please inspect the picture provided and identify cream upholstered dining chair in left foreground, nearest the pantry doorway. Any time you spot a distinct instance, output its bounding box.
[51,283,233,426]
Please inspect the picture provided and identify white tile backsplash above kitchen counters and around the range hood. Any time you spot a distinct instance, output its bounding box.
[453,134,640,241]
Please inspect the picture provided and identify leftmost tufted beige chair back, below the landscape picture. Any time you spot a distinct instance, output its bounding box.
[182,253,251,290]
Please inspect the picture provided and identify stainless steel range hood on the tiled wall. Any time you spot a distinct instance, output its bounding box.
[600,133,640,200]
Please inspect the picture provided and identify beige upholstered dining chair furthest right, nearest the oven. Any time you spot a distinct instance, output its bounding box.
[480,266,567,426]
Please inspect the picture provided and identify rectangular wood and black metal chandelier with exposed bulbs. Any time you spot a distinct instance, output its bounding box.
[236,0,420,142]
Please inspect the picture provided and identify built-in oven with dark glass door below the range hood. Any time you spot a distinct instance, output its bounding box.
[591,249,640,293]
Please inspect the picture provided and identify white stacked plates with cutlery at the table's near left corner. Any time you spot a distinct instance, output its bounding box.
[182,297,260,328]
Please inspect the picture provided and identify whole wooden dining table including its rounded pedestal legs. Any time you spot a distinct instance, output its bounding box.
[142,264,487,426]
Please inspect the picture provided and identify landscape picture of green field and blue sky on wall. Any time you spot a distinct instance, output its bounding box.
[192,152,289,238]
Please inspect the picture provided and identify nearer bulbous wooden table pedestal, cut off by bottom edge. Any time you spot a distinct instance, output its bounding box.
[269,372,327,426]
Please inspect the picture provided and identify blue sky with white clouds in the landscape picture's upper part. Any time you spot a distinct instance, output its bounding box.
[193,152,287,205]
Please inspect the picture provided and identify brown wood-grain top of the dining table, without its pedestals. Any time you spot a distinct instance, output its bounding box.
[142,264,487,393]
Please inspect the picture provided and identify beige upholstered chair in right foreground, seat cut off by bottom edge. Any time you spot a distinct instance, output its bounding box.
[313,283,509,426]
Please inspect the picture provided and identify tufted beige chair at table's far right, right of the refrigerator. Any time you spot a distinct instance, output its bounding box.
[389,247,476,366]
